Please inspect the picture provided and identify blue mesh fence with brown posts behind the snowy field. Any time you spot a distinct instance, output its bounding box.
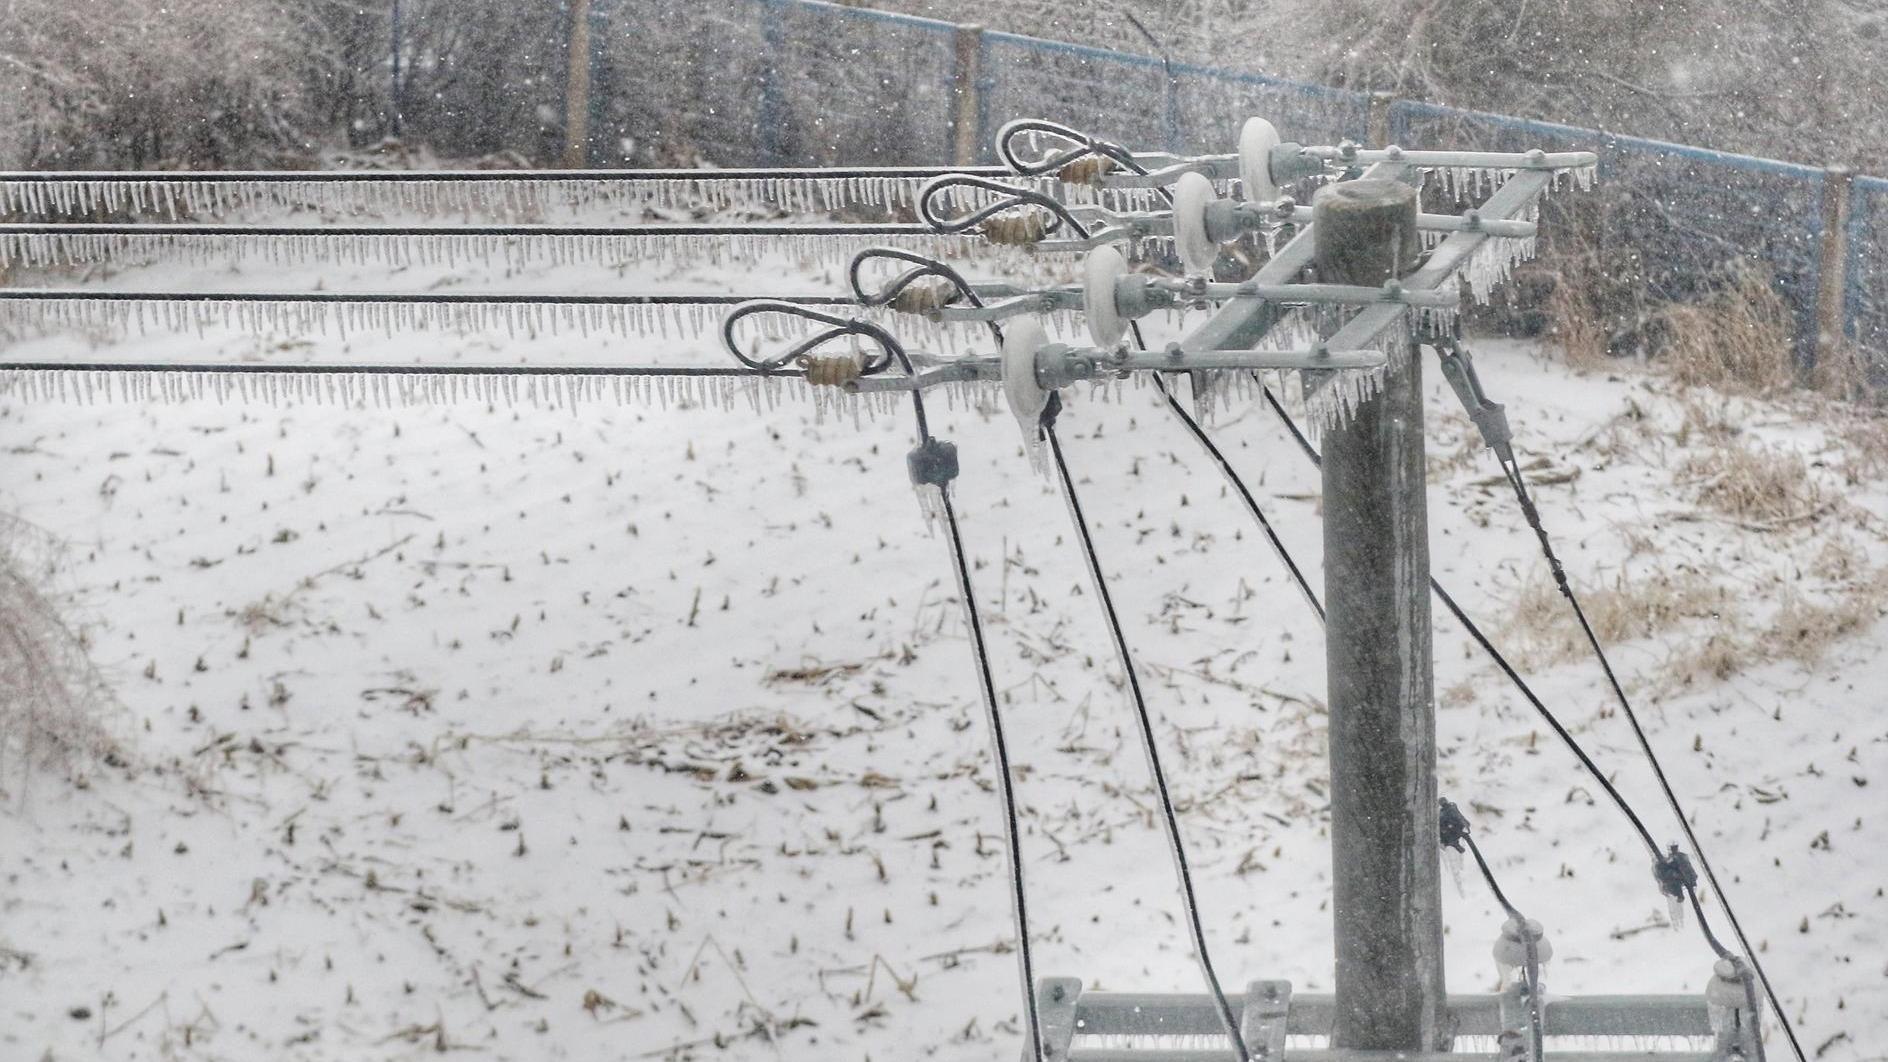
[614,0,1888,363]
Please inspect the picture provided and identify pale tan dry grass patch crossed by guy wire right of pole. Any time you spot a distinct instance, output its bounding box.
[1507,569,1731,665]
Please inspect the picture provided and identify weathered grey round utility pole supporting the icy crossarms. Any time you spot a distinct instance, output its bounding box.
[1312,180,1446,1051]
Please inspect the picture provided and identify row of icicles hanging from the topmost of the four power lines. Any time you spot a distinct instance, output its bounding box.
[0,166,1055,219]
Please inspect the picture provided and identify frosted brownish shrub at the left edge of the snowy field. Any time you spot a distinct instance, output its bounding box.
[0,518,119,784]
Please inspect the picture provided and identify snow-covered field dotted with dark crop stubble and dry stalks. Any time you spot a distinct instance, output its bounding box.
[0,219,1888,1062]
